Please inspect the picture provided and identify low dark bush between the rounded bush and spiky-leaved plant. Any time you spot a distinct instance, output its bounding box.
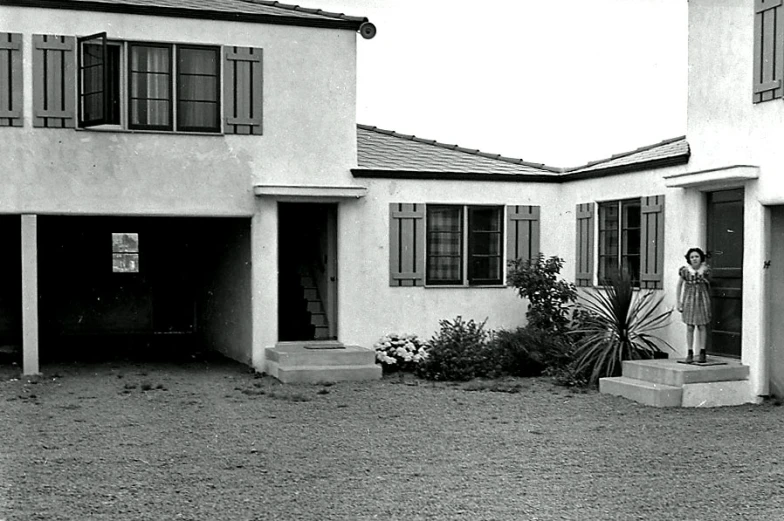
[487,326,571,376]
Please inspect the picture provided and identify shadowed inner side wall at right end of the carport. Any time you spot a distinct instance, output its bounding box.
[197,219,253,364]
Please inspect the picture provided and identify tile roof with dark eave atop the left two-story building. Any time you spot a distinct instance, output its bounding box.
[9,0,367,26]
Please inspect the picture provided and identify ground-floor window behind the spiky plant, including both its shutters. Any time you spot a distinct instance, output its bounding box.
[575,195,664,289]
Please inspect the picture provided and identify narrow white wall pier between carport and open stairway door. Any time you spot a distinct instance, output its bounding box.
[250,202,278,371]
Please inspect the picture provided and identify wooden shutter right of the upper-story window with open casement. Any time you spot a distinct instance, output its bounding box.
[223,47,263,134]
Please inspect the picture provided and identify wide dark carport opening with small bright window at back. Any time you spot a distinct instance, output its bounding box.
[38,216,251,363]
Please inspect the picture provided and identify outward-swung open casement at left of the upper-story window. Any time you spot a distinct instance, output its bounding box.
[77,33,120,128]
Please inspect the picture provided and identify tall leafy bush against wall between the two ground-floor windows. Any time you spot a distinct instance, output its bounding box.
[508,253,577,333]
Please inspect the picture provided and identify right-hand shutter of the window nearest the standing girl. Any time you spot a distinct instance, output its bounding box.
[640,195,664,289]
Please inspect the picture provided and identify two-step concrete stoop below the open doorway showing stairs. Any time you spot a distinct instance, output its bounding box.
[266,341,381,383]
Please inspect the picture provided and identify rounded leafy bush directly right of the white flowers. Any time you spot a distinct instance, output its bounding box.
[417,316,488,381]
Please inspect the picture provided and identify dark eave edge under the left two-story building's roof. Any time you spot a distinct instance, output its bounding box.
[1,0,367,31]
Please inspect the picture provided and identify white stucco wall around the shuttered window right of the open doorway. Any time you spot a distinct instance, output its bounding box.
[338,179,574,346]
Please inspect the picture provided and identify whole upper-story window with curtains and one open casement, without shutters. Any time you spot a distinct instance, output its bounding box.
[78,33,221,132]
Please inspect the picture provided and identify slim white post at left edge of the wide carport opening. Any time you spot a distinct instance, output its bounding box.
[22,215,40,375]
